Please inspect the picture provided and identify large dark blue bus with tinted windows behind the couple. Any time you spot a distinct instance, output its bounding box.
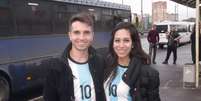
[0,0,131,96]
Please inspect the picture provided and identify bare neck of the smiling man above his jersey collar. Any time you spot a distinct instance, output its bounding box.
[70,49,89,63]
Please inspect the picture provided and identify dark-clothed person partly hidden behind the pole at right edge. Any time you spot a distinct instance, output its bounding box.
[191,25,201,64]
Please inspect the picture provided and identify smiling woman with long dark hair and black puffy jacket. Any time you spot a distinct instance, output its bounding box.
[104,22,160,101]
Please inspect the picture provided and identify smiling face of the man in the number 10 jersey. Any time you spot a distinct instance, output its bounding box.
[69,21,94,51]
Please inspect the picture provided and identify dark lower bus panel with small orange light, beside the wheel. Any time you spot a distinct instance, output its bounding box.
[9,57,50,93]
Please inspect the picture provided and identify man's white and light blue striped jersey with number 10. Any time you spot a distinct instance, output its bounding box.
[68,59,96,101]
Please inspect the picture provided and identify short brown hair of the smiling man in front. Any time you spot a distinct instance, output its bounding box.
[69,12,94,31]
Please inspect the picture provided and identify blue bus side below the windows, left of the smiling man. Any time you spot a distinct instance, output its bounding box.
[0,36,68,92]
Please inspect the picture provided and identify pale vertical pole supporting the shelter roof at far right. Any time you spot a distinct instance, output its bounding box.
[195,0,200,88]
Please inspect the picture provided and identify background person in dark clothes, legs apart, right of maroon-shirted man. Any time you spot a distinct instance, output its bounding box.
[162,27,181,64]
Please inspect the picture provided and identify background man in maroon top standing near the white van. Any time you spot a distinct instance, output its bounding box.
[147,25,159,64]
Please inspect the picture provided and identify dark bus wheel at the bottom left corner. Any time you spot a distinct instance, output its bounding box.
[0,75,10,101]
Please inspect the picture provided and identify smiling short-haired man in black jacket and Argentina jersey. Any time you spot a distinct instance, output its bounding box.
[44,13,105,101]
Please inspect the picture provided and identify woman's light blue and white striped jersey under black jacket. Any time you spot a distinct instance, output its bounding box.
[104,65,132,101]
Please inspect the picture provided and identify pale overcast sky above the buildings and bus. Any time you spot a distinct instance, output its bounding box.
[102,0,196,20]
